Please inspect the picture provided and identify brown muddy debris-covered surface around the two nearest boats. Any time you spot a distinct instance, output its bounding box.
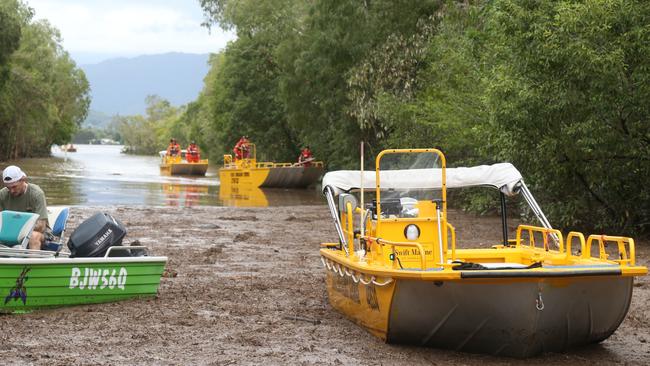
[0,206,650,366]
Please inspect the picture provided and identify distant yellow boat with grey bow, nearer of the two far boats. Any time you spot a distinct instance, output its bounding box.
[219,144,323,188]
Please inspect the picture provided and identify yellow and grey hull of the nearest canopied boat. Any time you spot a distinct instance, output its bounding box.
[327,263,633,358]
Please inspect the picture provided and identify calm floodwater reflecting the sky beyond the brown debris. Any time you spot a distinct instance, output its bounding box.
[0,145,324,207]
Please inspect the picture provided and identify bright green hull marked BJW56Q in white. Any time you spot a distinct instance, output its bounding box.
[0,257,167,313]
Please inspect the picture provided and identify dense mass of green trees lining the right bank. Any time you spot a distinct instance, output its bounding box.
[189,0,650,234]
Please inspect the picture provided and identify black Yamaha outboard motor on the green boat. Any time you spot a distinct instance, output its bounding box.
[68,212,130,257]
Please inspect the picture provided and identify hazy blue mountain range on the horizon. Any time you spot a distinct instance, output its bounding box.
[80,52,210,125]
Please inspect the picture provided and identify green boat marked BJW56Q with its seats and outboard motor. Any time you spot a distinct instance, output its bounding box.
[0,208,167,313]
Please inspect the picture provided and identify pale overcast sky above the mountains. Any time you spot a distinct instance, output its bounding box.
[27,0,234,65]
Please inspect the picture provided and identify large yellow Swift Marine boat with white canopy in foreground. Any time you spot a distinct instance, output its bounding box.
[320,149,648,358]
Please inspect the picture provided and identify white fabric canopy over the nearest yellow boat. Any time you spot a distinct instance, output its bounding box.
[323,163,522,195]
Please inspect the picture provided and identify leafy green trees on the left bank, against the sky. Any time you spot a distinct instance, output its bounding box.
[0,0,89,160]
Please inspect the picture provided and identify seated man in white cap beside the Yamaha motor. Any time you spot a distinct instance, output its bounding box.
[0,165,48,249]
